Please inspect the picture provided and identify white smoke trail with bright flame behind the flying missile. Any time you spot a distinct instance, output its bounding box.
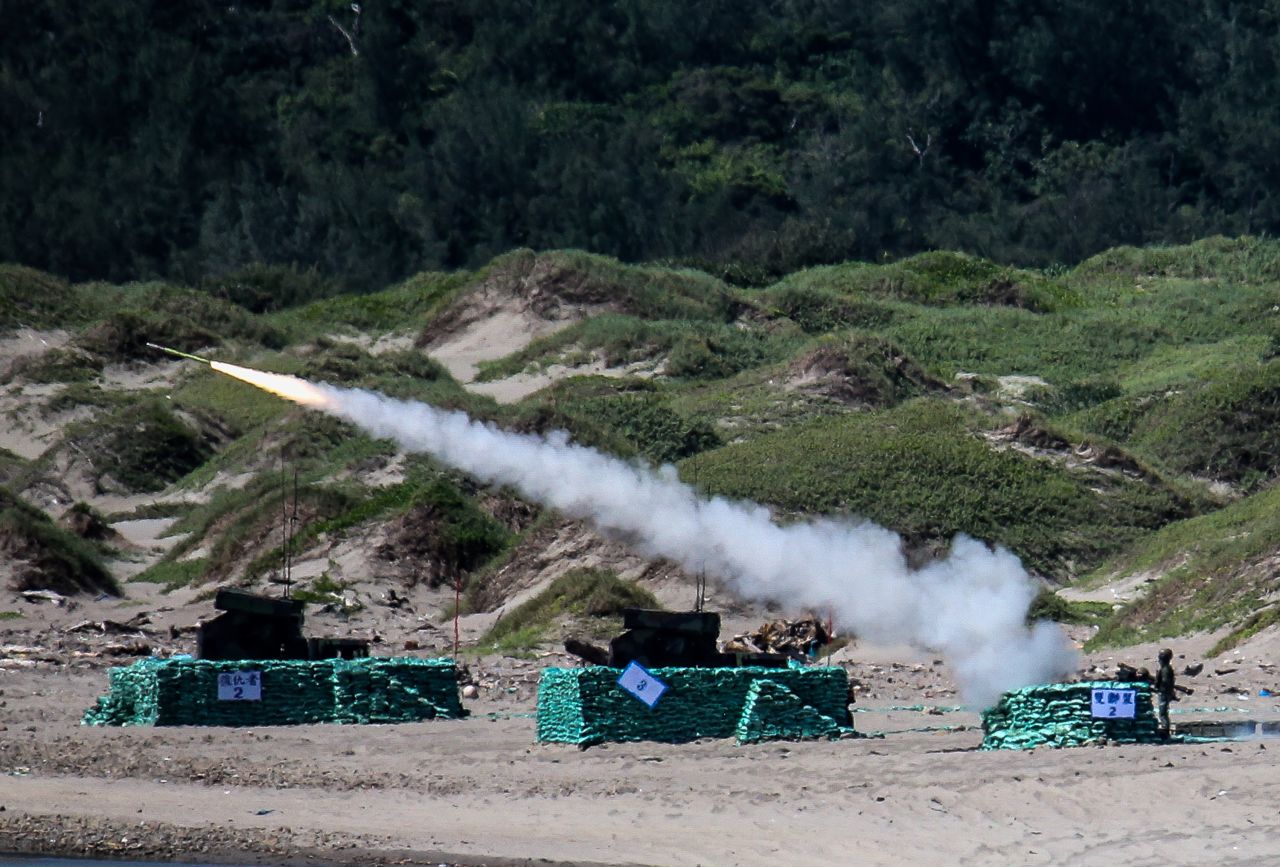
[223,365,1075,707]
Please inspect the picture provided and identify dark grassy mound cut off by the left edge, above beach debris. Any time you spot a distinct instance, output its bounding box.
[0,488,119,594]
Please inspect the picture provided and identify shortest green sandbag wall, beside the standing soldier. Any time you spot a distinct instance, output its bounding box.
[982,680,1162,749]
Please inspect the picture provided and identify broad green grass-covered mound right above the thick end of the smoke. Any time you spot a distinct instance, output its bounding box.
[682,400,1189,580]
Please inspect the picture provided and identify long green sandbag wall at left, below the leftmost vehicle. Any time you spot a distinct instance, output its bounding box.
[83,657,466,726]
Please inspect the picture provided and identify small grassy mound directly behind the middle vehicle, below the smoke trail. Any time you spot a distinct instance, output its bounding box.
[480,569,660,653]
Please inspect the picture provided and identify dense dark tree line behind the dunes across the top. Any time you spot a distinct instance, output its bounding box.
[0,0,1280,289]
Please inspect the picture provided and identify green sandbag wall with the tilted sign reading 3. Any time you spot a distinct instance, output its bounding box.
[538,666,852,744]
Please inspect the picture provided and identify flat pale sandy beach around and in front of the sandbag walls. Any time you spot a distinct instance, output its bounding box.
[0,614,1280,866]
